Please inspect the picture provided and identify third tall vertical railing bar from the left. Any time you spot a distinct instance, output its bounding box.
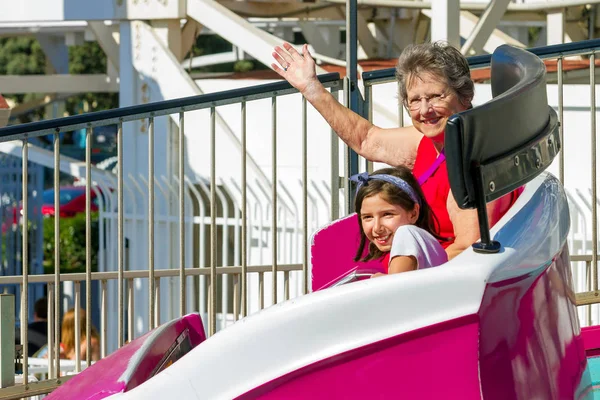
[85,124,92,366]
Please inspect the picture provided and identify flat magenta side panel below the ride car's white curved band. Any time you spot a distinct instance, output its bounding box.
[238,315,481,400]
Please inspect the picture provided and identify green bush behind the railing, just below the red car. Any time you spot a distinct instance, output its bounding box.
[43,213,98,274]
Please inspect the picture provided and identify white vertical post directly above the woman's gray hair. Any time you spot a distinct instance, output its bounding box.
[431,0,460,47]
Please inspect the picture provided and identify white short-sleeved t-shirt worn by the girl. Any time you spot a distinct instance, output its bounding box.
[390,225,448,269]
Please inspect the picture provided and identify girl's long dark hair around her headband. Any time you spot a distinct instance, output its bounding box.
[354,167,448,261]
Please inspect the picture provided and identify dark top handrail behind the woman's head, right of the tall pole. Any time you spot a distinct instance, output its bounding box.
[362,39,600,86]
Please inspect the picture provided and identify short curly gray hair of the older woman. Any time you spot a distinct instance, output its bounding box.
[396,42,475,108]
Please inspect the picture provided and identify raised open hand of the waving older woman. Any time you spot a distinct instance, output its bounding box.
[271,43,319,95]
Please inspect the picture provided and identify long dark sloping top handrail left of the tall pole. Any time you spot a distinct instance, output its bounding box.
[0,72,341,143]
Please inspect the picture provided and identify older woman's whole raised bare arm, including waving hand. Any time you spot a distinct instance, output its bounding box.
[271,43,423,169]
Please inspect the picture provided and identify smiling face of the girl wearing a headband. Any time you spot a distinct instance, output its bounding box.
[360,194,419,252]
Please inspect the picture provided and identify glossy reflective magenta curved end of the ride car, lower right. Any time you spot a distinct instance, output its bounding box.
[479,247,590,400]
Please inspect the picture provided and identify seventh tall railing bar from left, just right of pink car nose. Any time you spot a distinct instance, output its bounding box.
[208,107,217,336]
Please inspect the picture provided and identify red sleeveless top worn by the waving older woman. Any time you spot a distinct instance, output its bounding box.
[413,136,523,248]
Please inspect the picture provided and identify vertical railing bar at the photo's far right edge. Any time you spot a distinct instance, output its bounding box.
[590,53,598,290]
